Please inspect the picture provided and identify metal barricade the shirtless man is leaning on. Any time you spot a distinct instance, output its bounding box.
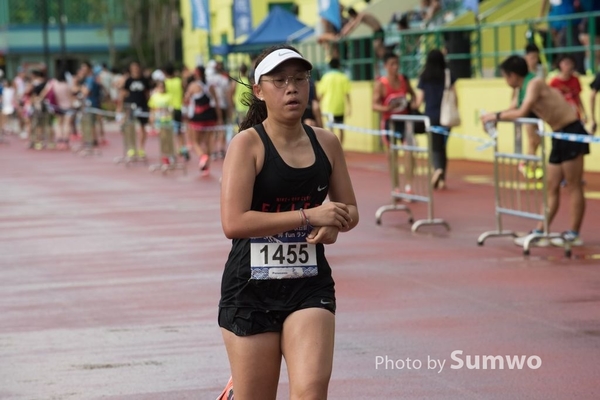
[477,118,571,257]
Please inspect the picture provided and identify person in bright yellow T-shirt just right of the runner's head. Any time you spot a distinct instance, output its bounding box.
[317,58,351,145]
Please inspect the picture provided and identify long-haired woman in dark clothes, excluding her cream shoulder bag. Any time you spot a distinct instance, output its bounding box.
[415,49,456,189]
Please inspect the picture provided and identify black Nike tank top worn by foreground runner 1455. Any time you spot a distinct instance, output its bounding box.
[219,124,333,310]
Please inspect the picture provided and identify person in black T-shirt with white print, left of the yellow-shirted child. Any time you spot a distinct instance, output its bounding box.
[119,61,150,158]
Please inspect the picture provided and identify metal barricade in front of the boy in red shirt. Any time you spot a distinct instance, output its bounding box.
[375,115,450,232]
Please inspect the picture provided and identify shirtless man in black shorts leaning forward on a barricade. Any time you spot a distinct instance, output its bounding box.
[481,56,590,246]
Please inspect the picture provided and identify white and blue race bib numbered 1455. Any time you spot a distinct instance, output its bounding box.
[250,227,318,280]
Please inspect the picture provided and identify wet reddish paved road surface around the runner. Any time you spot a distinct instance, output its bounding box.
[0,133,600,400]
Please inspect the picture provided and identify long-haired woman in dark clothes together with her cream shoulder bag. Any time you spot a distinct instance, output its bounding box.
[416,50,460,189]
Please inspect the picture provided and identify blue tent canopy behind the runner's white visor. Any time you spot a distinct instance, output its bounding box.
[229,7,314,53]
